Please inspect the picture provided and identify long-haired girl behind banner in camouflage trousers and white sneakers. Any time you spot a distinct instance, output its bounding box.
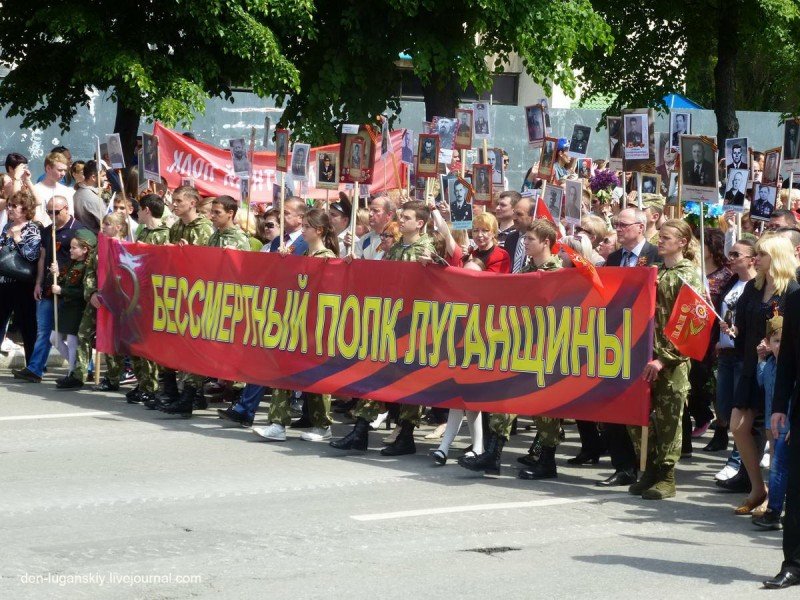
[253,208,339,442]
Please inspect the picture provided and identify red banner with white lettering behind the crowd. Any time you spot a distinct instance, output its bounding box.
[153,123,407,202]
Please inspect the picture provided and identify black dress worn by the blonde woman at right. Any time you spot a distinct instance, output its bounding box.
[733,279,800,413]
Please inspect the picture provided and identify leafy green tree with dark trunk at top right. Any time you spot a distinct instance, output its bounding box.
[573,0,800,140]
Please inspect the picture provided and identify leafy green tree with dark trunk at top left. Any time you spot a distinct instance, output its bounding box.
[0,0,313,164]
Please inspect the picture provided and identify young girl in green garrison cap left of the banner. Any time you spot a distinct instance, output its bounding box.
[50,229,97,372]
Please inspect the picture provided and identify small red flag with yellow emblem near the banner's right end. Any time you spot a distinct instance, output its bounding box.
[664,283,716,360]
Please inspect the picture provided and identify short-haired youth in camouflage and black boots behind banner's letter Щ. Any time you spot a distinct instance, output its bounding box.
[458,219,563,479]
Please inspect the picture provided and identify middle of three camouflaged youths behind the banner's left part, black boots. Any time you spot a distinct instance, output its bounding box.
[159,186,214,417]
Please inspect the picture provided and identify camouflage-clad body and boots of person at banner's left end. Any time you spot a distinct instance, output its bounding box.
[56,229,122,391]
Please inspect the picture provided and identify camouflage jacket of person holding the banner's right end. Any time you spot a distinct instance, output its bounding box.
[653,258,703,368]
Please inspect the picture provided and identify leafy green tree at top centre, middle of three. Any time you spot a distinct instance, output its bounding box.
[278,0,612,143]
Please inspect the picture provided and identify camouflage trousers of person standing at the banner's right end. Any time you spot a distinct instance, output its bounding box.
[628,361,689,469]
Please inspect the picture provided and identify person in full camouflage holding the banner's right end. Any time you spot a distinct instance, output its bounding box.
[628,220,702,500]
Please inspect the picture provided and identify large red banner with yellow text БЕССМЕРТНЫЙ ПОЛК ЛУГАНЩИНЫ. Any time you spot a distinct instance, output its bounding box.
[97,236,656,425]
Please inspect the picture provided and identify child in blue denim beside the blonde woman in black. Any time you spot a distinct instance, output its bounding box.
[753,316,789,529]
